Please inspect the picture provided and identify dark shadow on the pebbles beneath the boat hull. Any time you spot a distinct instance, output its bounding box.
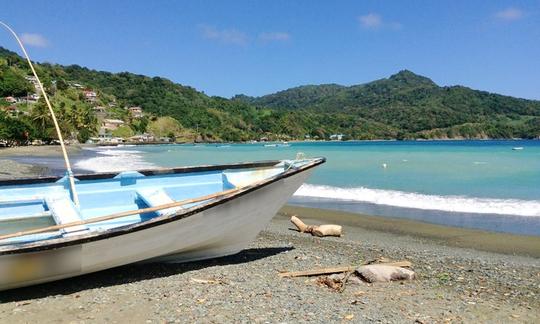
[0,246,294,303]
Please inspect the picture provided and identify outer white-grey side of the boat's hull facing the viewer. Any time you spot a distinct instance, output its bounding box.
[0,169,311,290]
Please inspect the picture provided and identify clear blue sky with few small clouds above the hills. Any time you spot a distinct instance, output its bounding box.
[0,0,540,99]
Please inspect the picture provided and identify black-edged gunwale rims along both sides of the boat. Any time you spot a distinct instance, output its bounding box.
[0,157,326,256]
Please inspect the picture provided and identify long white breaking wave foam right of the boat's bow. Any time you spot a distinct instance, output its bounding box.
[294,184,540,216]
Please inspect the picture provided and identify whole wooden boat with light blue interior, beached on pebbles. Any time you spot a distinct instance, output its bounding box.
[0,158,325,290]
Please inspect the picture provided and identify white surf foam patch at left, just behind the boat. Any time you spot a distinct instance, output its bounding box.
[75,147,157,172]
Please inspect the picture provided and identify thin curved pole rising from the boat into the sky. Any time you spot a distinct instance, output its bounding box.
[0,21,79,206]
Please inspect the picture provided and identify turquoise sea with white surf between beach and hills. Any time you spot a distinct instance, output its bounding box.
[76,140,540,235]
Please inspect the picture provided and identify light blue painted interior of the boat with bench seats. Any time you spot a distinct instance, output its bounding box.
[0,161,296,245]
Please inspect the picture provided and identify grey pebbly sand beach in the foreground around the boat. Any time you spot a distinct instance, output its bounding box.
[0,206,540,323]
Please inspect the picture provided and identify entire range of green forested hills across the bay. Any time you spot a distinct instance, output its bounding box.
[0,47,540,141]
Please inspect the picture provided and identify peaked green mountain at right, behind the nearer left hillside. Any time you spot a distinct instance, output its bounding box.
[235,70,540,138]
